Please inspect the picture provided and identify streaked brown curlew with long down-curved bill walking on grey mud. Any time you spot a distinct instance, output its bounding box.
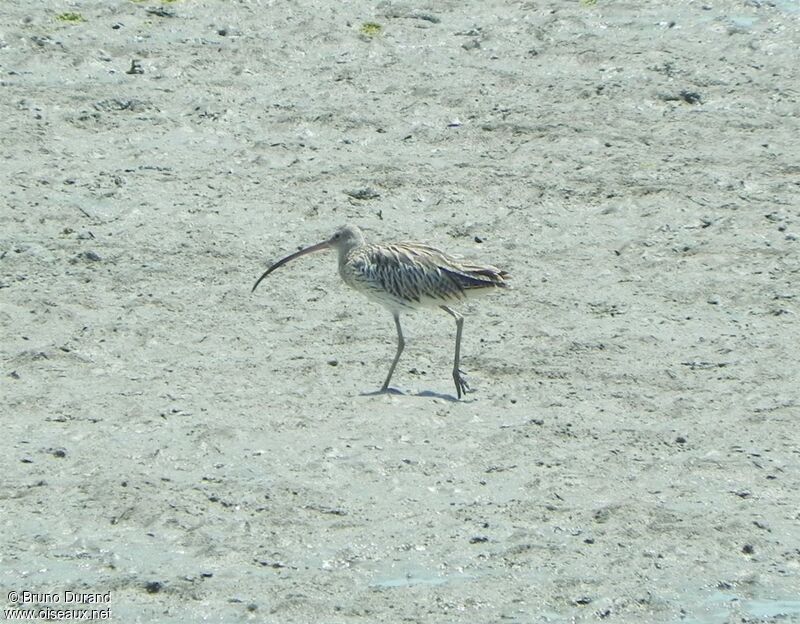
[251,225,509,399]
